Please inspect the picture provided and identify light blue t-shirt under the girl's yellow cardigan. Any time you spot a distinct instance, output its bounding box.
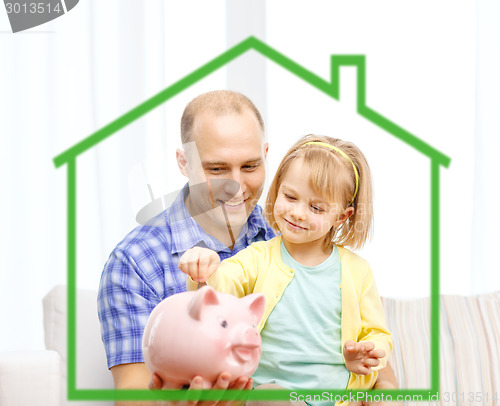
[253,242,349,389]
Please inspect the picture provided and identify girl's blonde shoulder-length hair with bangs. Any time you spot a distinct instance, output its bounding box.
[265,134,373,250]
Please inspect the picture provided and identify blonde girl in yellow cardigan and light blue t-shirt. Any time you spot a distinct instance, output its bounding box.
[179,135,392,398]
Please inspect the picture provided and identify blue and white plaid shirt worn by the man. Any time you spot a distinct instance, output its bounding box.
[97,187,274,368]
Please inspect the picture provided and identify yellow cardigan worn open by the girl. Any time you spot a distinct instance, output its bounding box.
[187,236,392,389]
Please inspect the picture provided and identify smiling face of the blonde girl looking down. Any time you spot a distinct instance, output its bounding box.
[273,158,352,246]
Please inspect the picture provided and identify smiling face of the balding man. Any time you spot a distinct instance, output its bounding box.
[181,109,267,237]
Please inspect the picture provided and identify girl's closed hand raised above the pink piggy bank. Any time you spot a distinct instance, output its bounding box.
[179,247,220,283]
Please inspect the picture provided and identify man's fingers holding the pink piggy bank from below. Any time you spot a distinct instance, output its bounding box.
[149,372,253,406]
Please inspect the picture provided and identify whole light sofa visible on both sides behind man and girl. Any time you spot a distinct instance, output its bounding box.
[0,286,500,406]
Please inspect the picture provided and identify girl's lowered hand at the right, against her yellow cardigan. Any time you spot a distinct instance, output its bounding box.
[343,340,385,375]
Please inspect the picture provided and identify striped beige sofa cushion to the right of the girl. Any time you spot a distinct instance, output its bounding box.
[383,292,500,404]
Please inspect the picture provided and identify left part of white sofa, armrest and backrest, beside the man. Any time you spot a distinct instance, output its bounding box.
[0,286,114,406]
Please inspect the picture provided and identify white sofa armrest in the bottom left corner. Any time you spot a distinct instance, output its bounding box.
[0,350,62,406]
